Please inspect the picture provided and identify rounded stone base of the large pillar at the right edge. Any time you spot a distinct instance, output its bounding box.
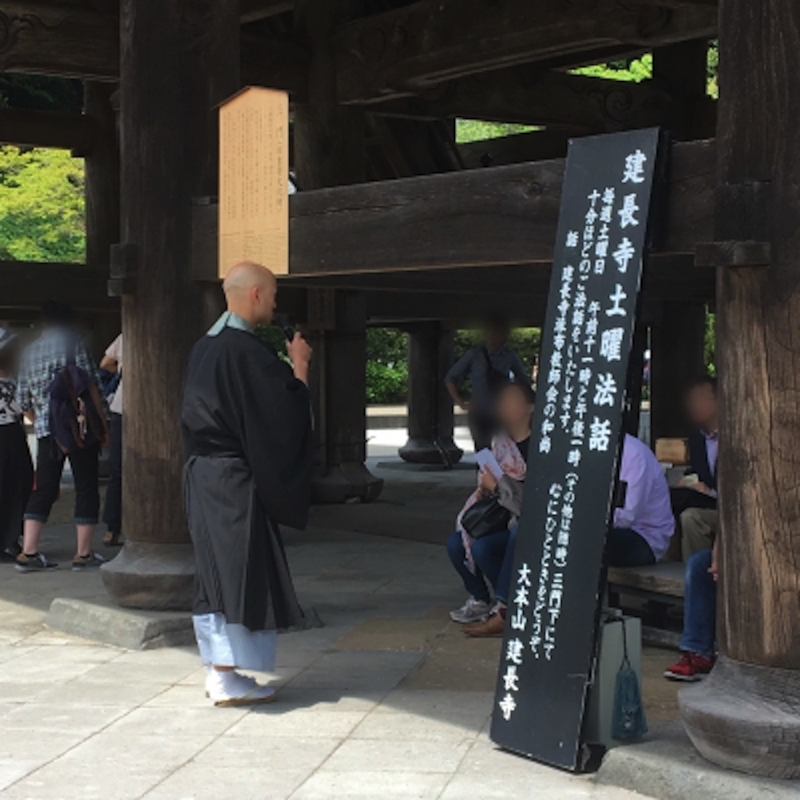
[678,657,800,779]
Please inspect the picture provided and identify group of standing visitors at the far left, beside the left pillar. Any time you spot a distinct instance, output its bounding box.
[0,301,122,573]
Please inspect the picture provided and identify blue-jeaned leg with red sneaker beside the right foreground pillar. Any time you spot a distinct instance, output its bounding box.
[664,541,718,681]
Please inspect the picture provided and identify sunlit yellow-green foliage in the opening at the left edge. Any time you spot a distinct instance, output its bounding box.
[0,147,86,262]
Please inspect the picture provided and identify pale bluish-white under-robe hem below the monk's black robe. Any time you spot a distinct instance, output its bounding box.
[192,613,278,672]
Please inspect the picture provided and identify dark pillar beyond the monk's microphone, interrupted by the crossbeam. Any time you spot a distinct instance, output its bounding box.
[294,0,383,503]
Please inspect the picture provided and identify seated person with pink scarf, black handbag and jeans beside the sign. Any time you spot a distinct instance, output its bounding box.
[447,383,534,623]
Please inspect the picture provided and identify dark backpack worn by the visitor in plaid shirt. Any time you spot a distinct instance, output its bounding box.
[47,356,106,455]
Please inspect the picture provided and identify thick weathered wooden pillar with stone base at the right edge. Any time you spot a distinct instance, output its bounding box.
[681,0,800,779]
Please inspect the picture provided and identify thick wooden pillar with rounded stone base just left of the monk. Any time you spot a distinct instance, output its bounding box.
[103,0,239,608]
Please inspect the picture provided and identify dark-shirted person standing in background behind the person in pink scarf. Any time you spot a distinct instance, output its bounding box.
[445,319,531,453]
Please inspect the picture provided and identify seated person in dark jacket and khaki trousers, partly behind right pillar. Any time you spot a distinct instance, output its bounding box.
[678,378,719,562]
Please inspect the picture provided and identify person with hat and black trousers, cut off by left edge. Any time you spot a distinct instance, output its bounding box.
[0,328,33,561]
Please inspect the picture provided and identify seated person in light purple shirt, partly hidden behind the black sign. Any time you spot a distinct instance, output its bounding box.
[606,435,675,567]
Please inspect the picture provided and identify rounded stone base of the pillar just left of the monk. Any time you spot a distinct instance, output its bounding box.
[100,542,194,611]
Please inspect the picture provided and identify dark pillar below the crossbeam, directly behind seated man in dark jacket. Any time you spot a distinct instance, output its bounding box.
[650,302,706,442]
